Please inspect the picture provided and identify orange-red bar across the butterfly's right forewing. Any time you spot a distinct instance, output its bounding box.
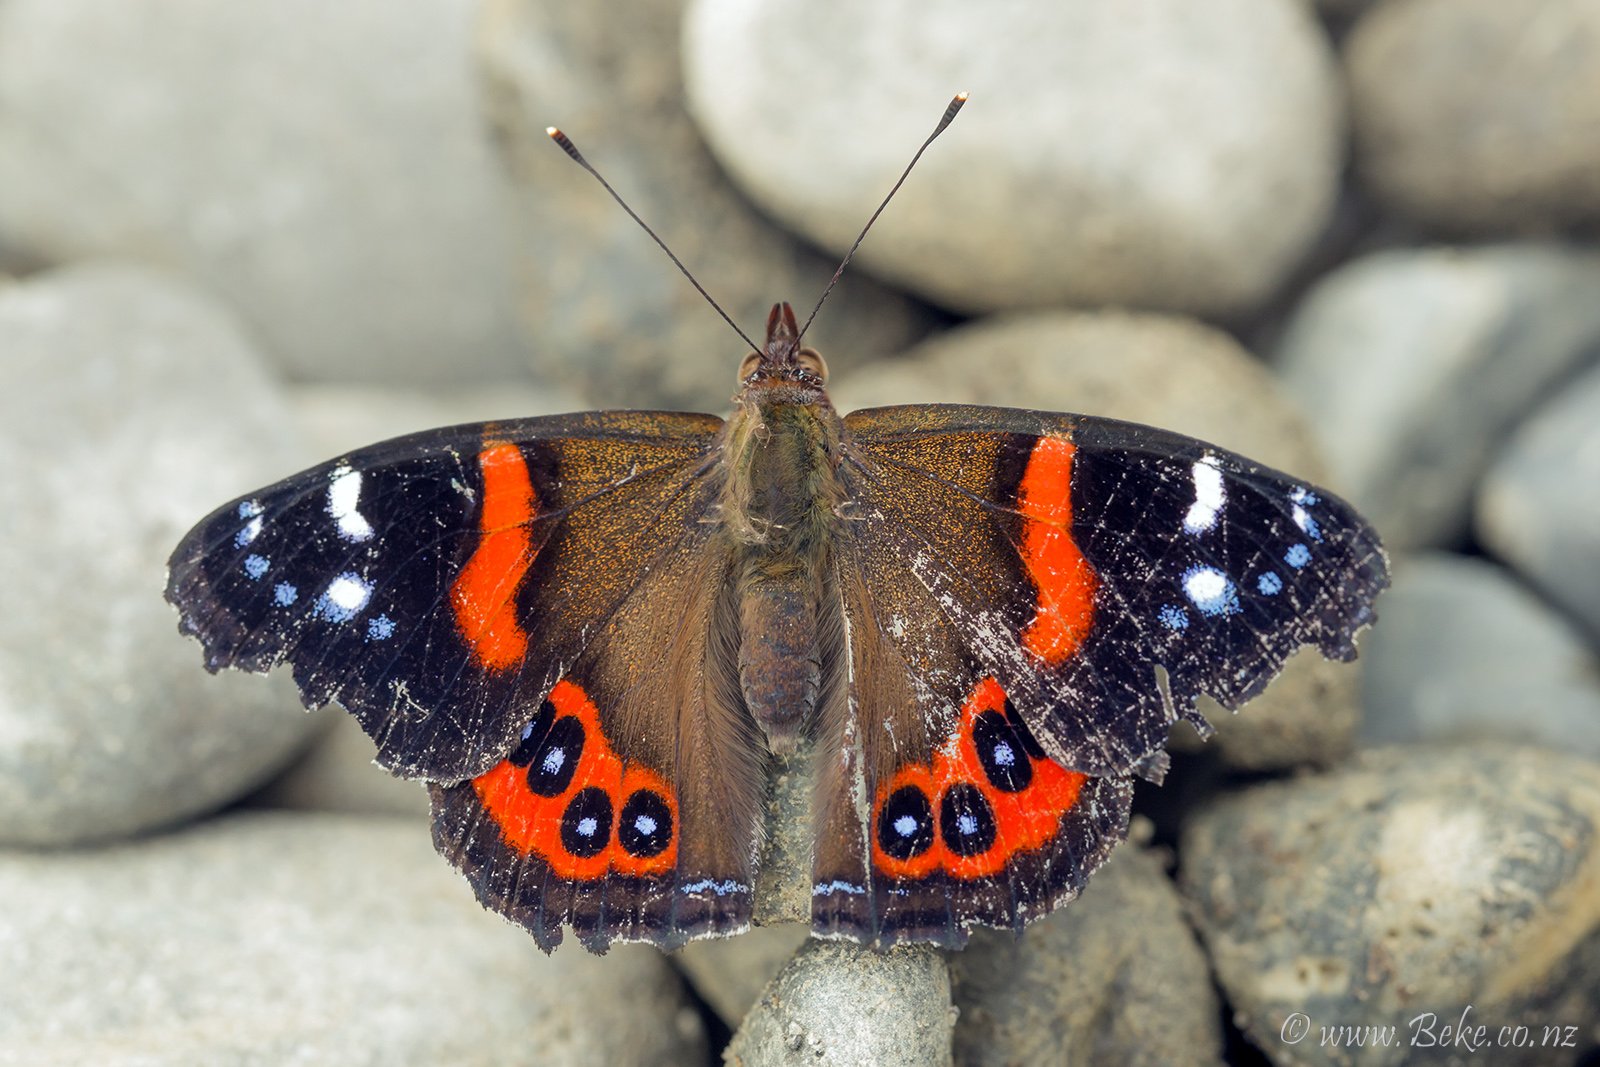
[1016,437,1099,667]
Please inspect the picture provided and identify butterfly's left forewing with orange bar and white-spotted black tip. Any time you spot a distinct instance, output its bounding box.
[166,413,720,781]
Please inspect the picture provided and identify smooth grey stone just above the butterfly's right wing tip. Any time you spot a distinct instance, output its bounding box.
[1277,243,1600,550]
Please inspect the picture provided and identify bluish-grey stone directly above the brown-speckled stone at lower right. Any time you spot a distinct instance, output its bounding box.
[1362,556,1600,760]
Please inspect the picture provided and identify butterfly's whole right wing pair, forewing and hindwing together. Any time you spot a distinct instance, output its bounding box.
[813,406,1387,944]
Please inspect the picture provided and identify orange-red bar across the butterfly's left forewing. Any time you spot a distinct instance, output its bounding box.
[450,442,539,670]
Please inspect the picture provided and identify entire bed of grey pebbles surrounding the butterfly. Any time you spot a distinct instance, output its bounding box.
[0,0,1600,1064]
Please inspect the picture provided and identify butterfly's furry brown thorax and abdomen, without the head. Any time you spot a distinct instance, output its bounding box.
[722,390,843,753]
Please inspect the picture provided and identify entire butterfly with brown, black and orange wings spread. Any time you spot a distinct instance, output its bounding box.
[166,99,1387,952]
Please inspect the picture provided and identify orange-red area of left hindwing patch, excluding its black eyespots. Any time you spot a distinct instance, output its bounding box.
[472,680,678,881]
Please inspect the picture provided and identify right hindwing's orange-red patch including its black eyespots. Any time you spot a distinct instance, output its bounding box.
[870,678,1088,878]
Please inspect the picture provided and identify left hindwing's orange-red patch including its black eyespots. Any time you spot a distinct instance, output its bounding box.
[472,678,678,881]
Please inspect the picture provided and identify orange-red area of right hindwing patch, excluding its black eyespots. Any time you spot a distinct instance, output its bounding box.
[870,678,1088,878]
